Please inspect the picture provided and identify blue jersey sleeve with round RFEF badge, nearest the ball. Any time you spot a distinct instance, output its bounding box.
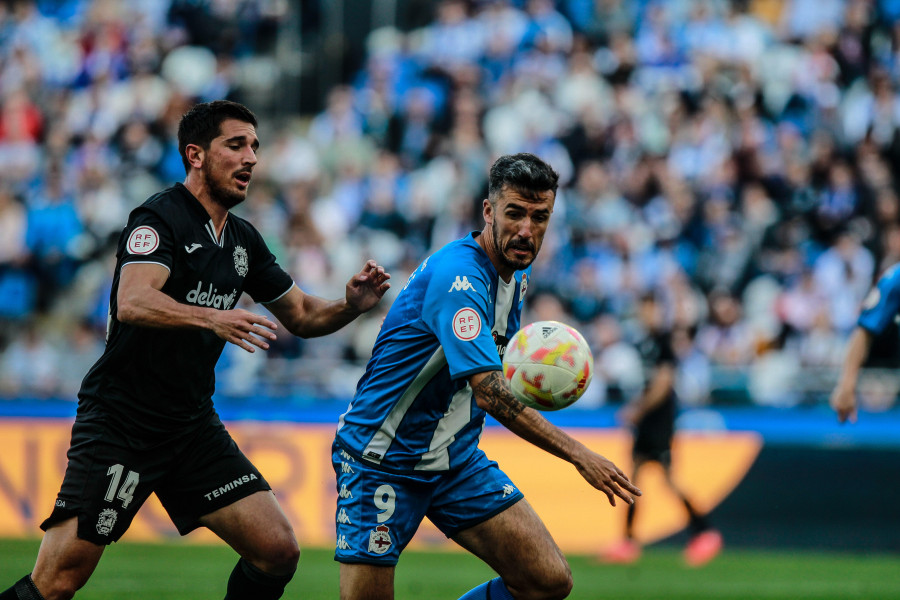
[422,258,502,379]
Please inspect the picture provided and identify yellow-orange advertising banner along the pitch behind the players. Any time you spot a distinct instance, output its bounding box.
[0,419,762,553]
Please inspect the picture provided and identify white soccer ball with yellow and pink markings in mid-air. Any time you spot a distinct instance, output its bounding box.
[503,321,594,410]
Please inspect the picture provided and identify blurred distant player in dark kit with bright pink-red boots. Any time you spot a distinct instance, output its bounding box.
[600,293,722,566]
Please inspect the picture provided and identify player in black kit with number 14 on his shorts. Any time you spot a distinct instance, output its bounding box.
[0,101,390,600]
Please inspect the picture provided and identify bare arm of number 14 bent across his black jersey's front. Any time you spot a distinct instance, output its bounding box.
[116,263,277,352]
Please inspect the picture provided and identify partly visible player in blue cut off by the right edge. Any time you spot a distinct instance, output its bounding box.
[830,264,900,423]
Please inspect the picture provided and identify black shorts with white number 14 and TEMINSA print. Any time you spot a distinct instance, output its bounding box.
[41,416,271,545]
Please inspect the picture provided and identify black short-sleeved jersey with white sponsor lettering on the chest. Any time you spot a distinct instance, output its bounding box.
[79,183,293,439]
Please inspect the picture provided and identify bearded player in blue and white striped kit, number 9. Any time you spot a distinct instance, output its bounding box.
[333,154,640,600]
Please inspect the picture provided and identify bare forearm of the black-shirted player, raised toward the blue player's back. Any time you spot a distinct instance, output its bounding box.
[266,260,391,338]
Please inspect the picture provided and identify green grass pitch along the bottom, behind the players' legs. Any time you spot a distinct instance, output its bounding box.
[0,540,900,600]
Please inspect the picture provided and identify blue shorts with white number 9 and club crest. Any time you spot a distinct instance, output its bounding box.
[331,444,523,565]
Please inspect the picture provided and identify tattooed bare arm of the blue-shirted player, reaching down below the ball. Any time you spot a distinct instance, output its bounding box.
[469,371,641,506]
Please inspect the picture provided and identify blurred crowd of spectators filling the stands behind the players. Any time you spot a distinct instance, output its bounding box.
[0,0,900,408]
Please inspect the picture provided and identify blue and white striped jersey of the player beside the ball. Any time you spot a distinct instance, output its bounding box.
[336,233,531,472]
